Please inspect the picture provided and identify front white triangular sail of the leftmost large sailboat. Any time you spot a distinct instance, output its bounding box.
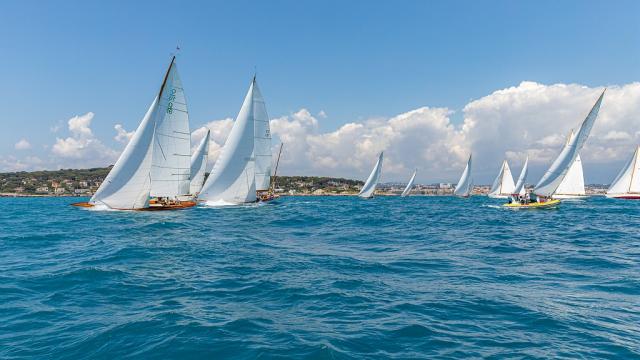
[89,96,158,210]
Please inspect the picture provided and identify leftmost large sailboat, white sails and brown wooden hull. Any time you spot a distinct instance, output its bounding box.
[72,56,195,210]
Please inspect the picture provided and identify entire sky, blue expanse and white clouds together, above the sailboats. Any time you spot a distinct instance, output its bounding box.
[0,1,640,183]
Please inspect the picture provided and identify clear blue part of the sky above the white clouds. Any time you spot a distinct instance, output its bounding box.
[0,1,640,183]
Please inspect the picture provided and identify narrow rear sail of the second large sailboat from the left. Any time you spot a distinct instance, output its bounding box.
[253,77,273,191]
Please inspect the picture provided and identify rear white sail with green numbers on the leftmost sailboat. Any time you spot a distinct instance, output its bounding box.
[150,57,191,197]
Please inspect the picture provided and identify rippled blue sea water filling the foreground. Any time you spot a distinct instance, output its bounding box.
[0,196,640,359]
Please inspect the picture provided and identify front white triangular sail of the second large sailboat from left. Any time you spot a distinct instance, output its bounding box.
[198,79,256,204]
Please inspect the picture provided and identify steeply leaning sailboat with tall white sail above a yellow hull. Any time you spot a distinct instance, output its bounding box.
[504,91,604,209]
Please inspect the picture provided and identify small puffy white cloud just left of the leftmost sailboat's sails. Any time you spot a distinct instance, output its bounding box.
[51,112,118,167]
